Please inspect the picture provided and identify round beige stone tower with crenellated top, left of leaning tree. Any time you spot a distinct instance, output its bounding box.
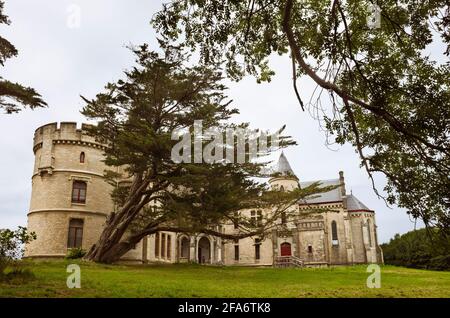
[25,122,114,257]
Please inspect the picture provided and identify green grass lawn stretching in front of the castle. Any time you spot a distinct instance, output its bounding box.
[0,260,450,297]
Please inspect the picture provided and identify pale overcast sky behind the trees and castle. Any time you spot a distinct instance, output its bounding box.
[0,0,426,242]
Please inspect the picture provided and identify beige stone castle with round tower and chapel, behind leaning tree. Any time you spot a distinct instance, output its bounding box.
[25,122,383,266]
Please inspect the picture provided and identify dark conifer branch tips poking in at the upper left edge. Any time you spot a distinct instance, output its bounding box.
[0,0,47,114]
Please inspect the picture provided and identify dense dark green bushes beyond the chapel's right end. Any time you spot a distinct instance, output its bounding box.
[381,229,450,270]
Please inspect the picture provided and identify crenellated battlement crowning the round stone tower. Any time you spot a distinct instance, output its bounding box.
[33,122,106,152]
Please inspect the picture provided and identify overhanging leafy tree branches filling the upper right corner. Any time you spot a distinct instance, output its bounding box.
[152,0,450,235]
